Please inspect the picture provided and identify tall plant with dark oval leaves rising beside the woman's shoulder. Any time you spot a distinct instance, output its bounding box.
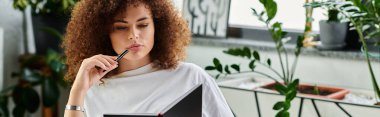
[205,0,304,117]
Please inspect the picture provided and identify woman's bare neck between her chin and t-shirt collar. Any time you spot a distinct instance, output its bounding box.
[117,55,151,73]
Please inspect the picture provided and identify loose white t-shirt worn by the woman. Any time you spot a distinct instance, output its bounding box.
[84,62,233,117]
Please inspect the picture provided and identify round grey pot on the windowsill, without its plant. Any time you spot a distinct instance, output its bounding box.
[318,20,347,49]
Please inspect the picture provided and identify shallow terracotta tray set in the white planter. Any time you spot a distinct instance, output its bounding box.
[262,82,350,100]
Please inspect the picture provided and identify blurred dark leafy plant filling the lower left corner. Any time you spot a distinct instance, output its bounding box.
[0,50,67,117]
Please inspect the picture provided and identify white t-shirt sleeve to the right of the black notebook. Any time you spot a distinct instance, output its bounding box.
[197,64,234,117]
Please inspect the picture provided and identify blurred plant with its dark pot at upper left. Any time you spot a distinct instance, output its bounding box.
[13,0,78,54]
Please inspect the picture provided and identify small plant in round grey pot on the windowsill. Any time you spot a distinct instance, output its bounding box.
[319,7,348,49]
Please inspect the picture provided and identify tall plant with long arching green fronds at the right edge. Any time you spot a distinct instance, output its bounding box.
[307,0,380,101]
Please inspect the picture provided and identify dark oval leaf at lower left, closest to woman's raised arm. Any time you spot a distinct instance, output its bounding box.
[42,78,60,107]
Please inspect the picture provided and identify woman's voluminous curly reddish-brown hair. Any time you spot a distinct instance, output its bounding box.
[62,0,191,83]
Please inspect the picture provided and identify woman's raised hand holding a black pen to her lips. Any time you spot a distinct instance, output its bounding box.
[71,54,118,93]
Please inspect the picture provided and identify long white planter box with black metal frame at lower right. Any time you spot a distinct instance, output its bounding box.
[218,78,380,117]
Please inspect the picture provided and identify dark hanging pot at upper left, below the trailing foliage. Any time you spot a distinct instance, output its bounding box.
[32,15,69,54]
